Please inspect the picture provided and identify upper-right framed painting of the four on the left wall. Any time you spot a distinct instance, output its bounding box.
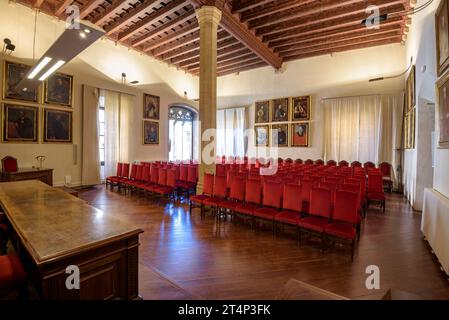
[44,73,73,107]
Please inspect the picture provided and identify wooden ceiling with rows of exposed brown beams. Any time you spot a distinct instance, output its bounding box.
[17,0,415,76]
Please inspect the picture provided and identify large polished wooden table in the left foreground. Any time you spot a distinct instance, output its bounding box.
[0,180,143,299]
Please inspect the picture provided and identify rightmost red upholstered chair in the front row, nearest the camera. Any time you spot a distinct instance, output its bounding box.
[325,191,359,260]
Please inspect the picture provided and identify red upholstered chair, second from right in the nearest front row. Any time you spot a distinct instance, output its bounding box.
[298,188,332,249]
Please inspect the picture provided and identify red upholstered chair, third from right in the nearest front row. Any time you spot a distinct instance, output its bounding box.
[274,184,302,237]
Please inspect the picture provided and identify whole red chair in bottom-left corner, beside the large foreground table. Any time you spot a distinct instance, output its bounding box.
[0,253,28,295]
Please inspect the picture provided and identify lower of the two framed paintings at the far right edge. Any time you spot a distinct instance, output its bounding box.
[436,72,449,148]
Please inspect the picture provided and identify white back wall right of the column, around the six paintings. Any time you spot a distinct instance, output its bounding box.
[217,44,405,159]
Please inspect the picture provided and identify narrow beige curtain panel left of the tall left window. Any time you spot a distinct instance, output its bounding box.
[81,85,100,186]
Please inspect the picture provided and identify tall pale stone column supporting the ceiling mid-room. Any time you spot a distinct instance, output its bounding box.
[196,6,221,193]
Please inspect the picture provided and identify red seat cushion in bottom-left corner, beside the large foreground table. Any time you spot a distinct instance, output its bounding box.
[0,254,27,290]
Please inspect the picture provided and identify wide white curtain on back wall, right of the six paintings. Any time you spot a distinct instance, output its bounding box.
[324,93,404,185]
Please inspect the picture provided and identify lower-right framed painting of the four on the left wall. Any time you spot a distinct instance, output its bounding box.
[44,109,73,143]
